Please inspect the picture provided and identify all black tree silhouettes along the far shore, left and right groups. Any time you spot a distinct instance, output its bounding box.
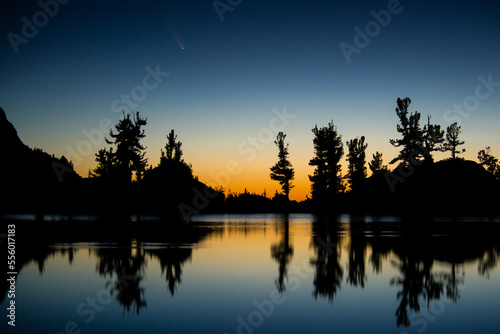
[89,97,500,204]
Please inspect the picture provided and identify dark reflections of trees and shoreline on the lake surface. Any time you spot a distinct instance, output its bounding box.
[1,216,500,327]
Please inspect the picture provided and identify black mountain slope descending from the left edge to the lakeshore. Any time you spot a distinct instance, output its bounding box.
[0,108,223,217]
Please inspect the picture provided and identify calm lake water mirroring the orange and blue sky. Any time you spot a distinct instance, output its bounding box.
[0,214,500,334]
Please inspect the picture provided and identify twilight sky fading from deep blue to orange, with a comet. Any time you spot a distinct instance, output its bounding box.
[0,0,500,200]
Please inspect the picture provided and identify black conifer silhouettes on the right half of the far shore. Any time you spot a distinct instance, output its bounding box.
[270,97,500,199]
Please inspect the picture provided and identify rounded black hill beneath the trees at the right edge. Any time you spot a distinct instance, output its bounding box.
[352,159,500,219]
